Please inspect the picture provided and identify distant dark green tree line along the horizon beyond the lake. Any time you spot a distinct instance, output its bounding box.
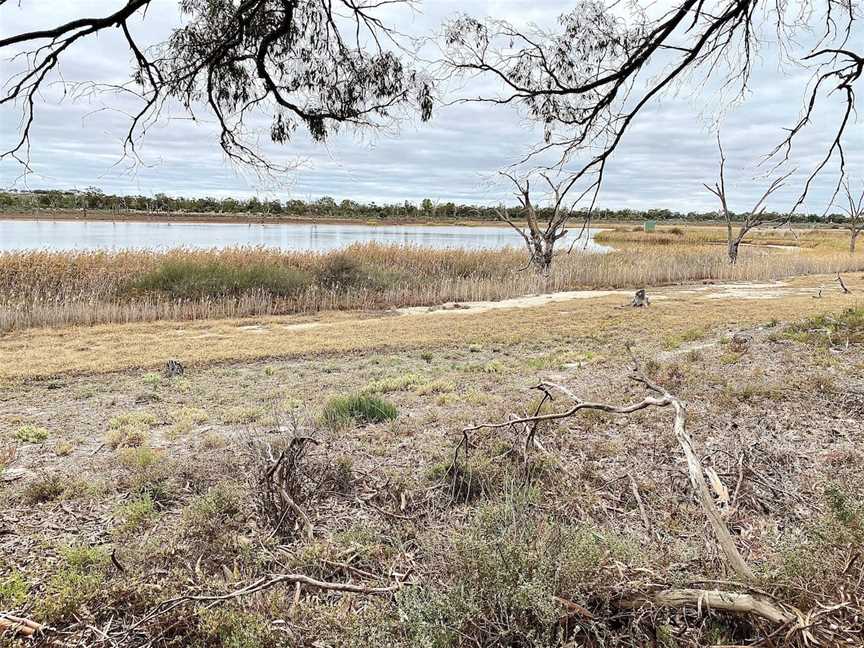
[0,187,847,223]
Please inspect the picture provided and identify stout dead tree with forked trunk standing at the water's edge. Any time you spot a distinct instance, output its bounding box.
[497,173,595,275]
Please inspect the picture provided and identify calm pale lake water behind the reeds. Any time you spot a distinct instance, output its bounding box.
[0,219,608,252]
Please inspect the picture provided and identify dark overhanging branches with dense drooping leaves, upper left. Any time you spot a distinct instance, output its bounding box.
[0,0,432,171]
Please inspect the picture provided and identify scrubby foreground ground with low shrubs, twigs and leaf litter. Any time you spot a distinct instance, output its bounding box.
[0,298,864,648]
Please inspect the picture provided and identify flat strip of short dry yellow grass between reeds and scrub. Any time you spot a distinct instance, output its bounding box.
[0,273,864,382]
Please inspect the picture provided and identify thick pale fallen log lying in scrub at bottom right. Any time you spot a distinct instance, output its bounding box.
[618,589,799,625]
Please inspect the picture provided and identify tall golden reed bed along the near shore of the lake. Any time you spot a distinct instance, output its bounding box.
[0,237,864,331]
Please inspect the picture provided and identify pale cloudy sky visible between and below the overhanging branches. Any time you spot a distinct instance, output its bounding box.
[0,0,864,212]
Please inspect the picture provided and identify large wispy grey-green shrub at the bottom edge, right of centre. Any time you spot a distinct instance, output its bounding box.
[397,491,639,648]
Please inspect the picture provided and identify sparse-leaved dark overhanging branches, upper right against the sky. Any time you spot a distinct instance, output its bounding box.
[443,0,864,212]
